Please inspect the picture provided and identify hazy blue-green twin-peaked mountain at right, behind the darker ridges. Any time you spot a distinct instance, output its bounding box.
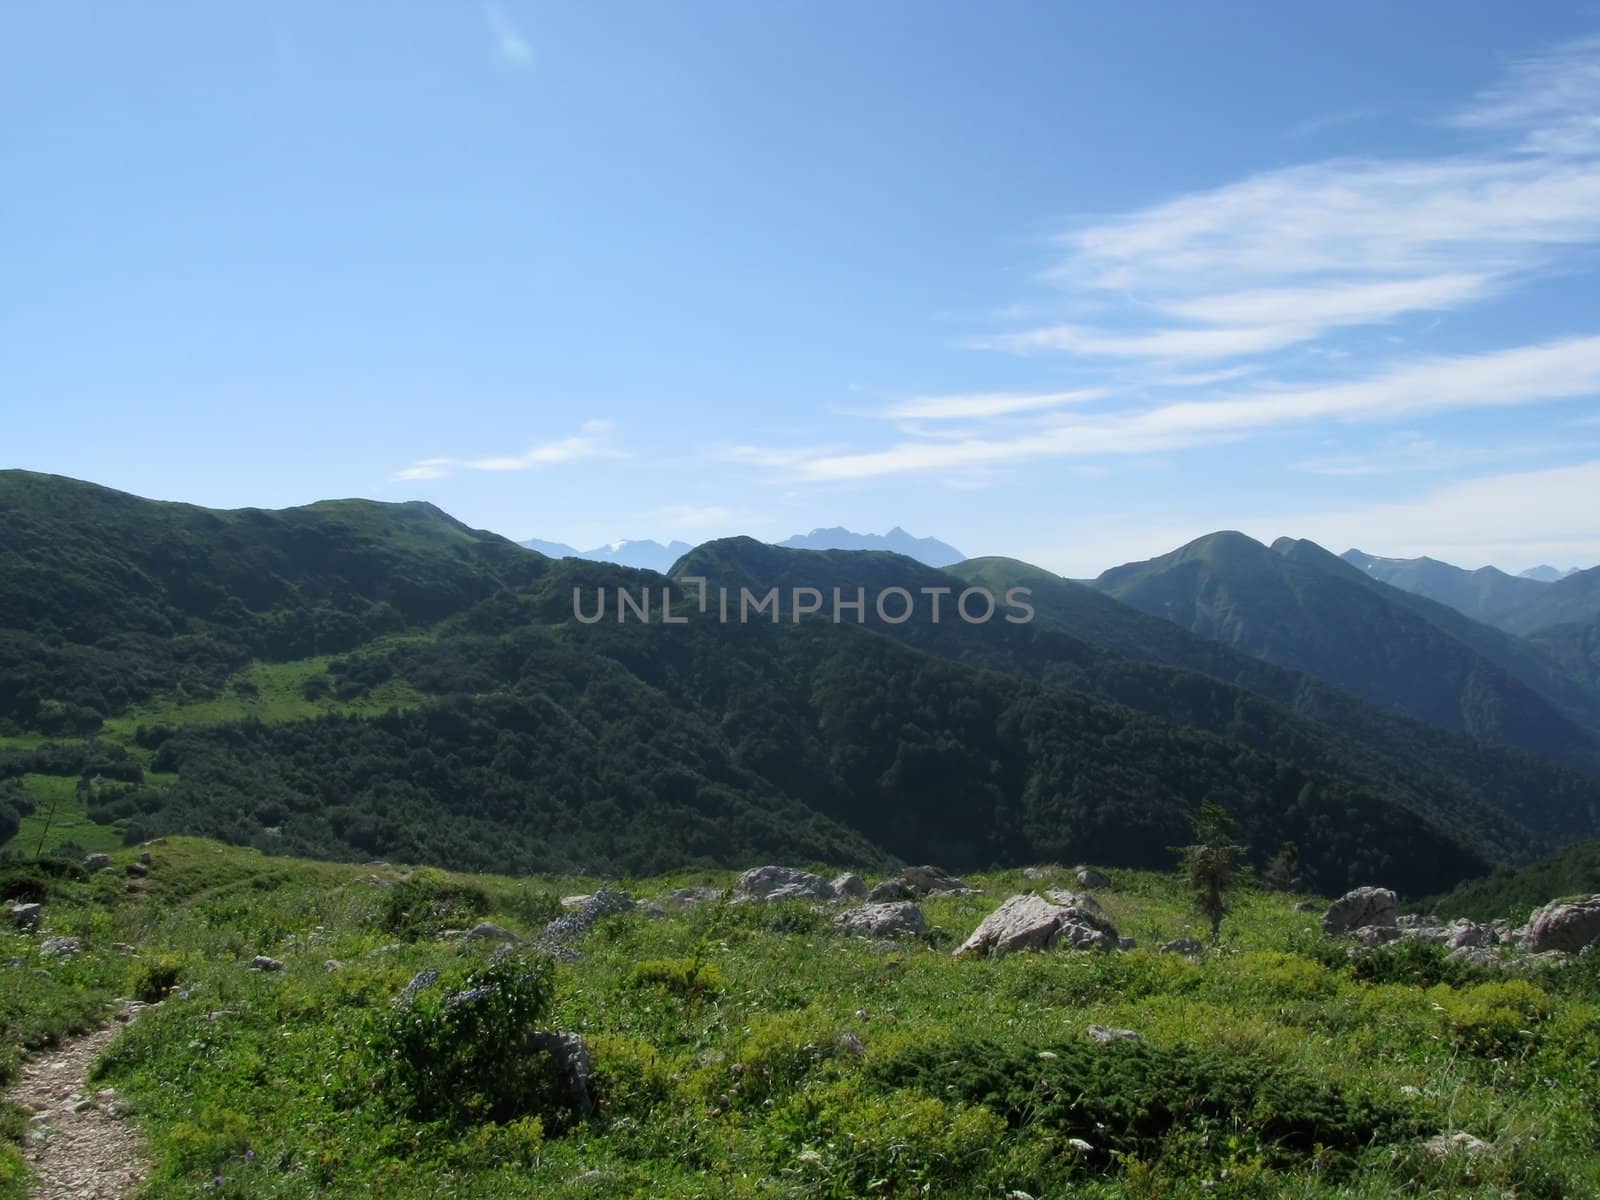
[1096,533,1600,773]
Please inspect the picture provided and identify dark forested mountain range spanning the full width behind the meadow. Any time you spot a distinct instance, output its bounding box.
[0,472,1600,893]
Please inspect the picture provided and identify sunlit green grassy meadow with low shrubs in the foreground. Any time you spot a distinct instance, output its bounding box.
[0,838,1600,1200]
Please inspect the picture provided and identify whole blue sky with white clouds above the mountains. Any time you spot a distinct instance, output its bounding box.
[0,0,1600,574]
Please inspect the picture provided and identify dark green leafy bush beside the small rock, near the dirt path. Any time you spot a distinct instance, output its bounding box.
[373,954,570,1128]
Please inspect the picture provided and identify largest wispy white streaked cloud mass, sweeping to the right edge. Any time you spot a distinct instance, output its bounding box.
[734,38,1600,482]
